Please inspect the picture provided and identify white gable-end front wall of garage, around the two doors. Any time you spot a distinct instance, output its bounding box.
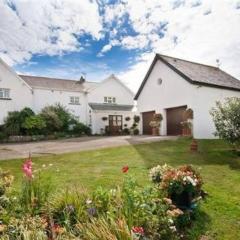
[137,61,193,135]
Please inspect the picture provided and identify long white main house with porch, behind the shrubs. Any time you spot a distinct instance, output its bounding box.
[0,57,134,135]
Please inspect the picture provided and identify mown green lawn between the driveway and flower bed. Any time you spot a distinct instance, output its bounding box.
[0,139,240,240]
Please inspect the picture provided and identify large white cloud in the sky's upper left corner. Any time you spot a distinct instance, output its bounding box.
[0,0,102,64]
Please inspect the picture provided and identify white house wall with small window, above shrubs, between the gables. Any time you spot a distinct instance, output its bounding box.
[33,89,87,123]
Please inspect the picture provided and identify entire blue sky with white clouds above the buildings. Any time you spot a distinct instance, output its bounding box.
[0,0,240,91]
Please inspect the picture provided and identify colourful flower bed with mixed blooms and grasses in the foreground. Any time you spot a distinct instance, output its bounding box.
[0,159,202,240]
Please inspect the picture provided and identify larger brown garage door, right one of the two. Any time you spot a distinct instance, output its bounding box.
[167,106,187,135]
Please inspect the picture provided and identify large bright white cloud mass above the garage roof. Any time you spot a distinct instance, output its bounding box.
[112,0,240,91]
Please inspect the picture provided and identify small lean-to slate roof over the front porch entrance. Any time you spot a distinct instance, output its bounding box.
[88,103,133,111]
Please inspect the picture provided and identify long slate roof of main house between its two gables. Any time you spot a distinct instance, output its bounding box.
[19,75,99,92]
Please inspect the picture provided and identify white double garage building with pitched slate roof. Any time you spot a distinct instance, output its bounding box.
[135,54,240,138]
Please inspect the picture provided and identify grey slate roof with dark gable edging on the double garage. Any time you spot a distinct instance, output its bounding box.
[135,54,240,100]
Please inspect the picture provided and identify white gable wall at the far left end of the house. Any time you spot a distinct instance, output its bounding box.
[0,61,33,124]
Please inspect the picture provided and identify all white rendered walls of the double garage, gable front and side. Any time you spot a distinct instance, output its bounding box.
[137,61,240,138]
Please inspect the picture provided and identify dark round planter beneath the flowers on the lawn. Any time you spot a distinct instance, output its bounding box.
[170,191,193,210]
